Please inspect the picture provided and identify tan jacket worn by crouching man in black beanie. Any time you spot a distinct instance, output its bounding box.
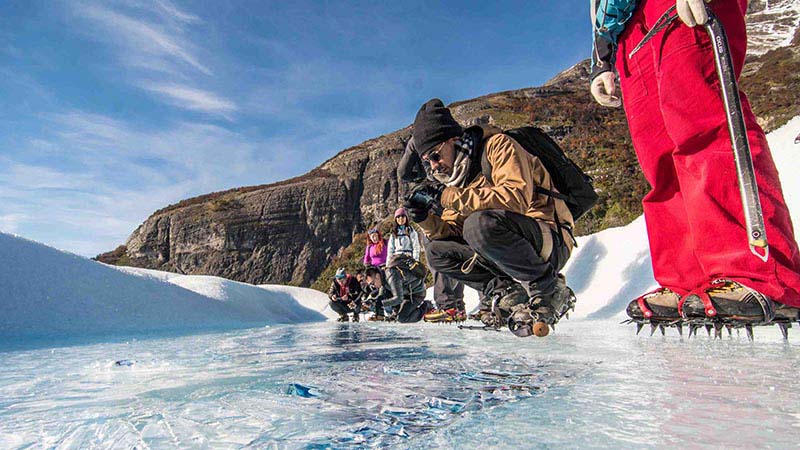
[419,126,574,251]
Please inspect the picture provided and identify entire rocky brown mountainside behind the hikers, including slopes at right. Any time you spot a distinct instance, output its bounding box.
[97,7,800,286]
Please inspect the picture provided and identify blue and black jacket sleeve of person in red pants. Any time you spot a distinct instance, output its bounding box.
[591,0,636,79]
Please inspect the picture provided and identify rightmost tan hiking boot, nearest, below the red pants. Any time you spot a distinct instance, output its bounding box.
[683,280,776,322]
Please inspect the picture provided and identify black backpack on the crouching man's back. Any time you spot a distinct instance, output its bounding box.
[481,127,598,220]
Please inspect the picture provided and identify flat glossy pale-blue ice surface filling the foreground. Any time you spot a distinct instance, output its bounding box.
[0,322,800,449]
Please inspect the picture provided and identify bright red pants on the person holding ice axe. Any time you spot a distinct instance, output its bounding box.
[617,0,800,306]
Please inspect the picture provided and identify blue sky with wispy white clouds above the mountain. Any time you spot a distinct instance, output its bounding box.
[0,0,590,256]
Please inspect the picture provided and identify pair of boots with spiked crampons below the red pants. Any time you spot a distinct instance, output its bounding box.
[622,279,800,340]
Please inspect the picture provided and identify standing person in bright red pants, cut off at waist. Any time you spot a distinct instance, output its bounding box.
[591,0,800,323]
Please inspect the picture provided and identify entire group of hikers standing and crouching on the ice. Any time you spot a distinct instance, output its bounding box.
[331,0,800,336]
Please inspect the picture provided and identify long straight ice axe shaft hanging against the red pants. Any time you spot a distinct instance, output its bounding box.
[705,7,769,262]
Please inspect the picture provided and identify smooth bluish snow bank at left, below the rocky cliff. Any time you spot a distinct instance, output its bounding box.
[0,233,326,347]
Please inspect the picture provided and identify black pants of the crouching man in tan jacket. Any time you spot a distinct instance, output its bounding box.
[425,209,569,295]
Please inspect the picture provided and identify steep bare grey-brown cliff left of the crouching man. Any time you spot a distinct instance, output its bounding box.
[107,132,407,285]
